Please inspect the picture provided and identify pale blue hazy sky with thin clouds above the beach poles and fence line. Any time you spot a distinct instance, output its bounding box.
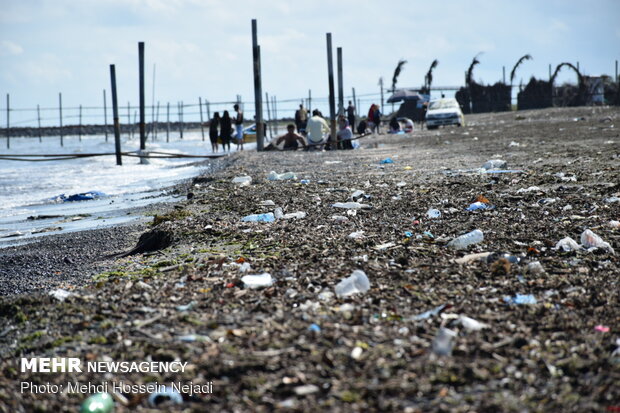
[0,0,620,126]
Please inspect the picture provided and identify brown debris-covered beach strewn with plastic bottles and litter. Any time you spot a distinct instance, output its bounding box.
[0,107,620,412]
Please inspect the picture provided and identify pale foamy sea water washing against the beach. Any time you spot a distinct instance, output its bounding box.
[0,131,245,247]
